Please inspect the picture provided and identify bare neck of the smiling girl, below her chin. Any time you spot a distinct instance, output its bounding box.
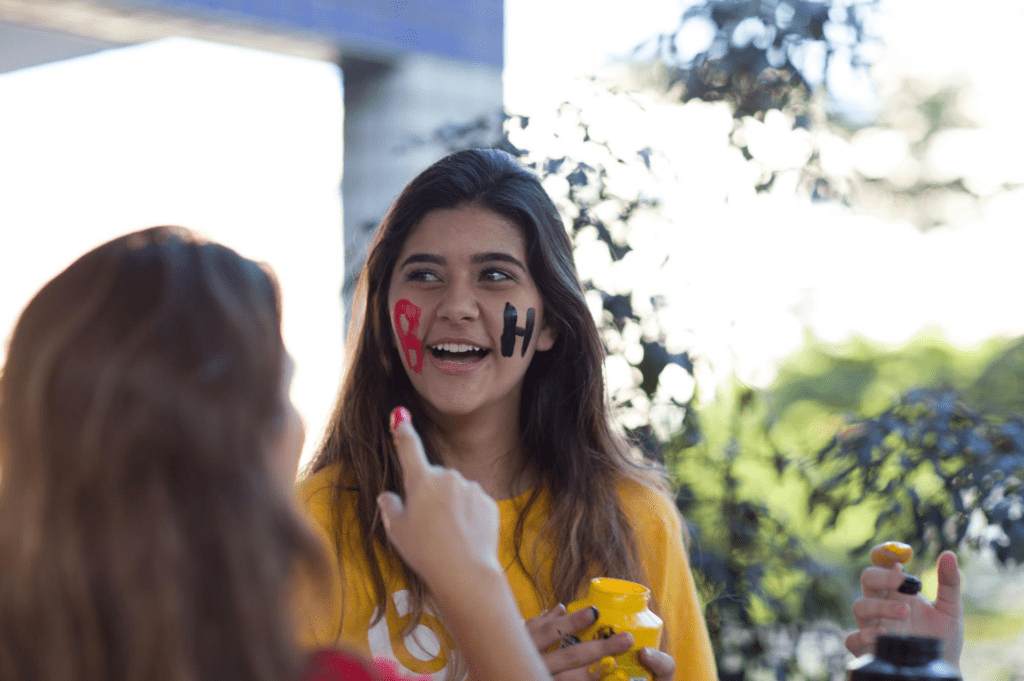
[423,409,537,501]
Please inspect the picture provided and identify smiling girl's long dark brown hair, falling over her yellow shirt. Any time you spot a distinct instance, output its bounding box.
[310,150,667,633]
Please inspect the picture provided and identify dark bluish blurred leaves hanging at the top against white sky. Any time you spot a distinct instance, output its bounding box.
[636,0,880,204]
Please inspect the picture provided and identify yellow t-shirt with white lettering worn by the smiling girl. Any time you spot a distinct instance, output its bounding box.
[299,466,718,681]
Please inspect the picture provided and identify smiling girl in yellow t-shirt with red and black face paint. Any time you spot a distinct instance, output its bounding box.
[301,150,716,681]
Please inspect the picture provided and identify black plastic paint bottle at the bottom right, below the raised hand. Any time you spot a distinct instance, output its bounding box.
[847,635,961,681]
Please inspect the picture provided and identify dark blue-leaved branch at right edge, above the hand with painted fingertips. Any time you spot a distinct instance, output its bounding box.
[808,388,1024,564]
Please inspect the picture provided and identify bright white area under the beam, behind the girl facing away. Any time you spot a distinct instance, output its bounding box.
[0,39,342,461]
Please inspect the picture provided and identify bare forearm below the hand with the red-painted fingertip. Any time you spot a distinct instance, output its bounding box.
[433,564,551,681]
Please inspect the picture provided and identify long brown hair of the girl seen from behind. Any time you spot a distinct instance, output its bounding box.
[0,227,324,681]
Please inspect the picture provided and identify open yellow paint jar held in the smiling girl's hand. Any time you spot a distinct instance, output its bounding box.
[565,577,663,681]
